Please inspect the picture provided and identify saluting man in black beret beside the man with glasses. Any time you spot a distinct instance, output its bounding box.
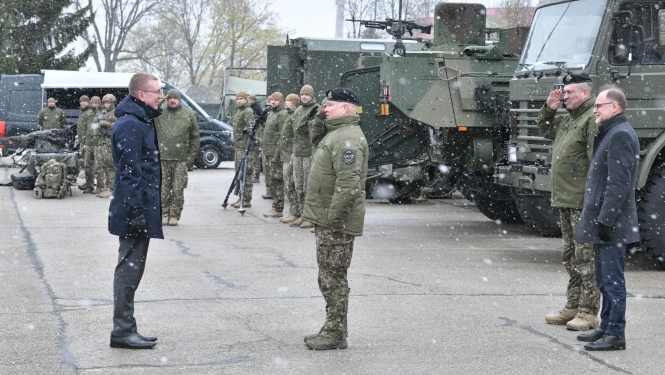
[538,73,600,331]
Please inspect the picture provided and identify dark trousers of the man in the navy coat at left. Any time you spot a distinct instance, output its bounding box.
[113,237,150,336]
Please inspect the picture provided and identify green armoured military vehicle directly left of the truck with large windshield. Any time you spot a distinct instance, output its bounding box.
[342,3,528,223]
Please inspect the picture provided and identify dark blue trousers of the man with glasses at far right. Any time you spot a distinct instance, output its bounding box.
[595,244,626,337]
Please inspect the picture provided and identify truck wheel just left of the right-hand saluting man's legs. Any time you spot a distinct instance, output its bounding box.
[515,196,561,237]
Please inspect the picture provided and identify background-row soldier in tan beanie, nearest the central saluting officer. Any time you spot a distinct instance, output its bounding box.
[289,85,319,228]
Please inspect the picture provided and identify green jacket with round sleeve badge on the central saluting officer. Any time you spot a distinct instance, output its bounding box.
[302,115,369,236]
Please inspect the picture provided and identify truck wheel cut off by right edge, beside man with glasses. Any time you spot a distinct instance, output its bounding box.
[637,166,665,264]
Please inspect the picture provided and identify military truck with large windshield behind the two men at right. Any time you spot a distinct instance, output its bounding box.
[495,0,665,263]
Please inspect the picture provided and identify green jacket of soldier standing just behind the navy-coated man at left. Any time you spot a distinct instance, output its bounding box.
[155,105,200,161]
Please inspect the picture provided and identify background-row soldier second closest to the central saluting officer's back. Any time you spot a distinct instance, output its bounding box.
[271,94,302,224]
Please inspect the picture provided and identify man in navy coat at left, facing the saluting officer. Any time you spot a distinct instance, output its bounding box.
[109,73,164,349]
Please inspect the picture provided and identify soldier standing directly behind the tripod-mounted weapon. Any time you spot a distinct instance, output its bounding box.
[231,91,257,208]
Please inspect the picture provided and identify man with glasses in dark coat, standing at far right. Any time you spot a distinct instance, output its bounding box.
[575,86,640,351]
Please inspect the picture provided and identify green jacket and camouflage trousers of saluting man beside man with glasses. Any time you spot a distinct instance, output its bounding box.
[538,96,600,315]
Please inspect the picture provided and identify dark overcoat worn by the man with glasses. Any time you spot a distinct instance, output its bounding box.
[575,113,640,244]
